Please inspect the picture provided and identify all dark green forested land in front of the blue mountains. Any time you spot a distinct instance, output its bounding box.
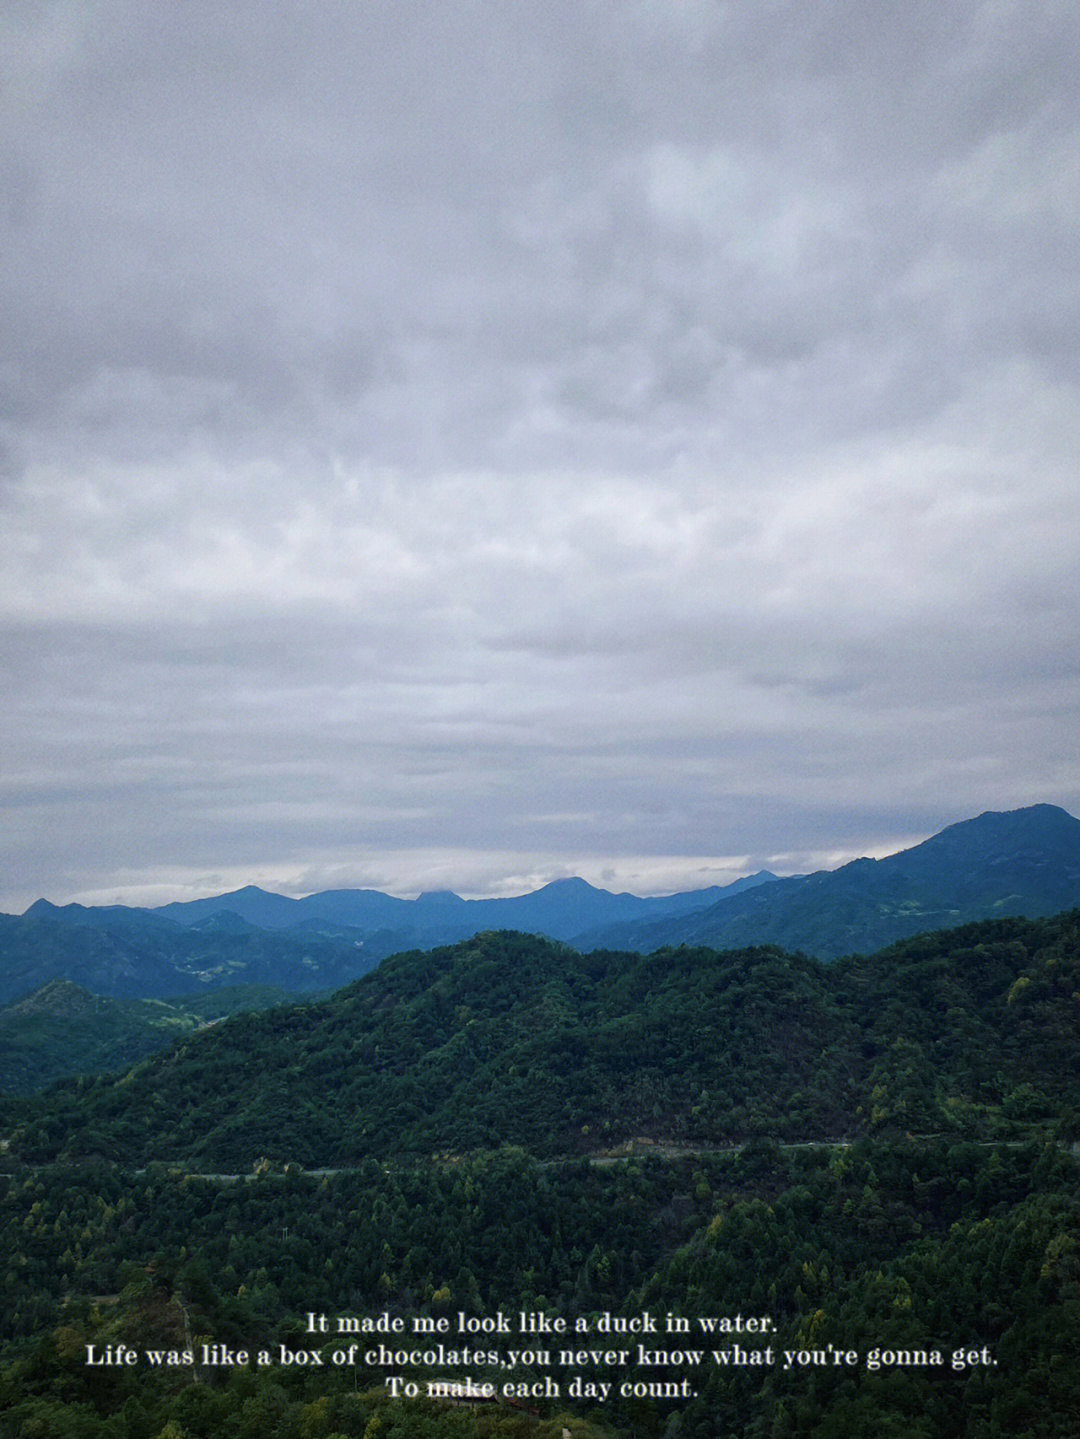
[0,912,1080,1439]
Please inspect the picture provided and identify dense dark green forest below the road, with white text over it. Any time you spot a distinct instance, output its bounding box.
[0,1141,1080,1439]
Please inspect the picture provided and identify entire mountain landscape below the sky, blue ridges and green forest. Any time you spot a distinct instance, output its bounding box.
[0,806,1080,1439]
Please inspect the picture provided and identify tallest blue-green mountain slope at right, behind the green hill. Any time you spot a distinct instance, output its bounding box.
[574,804,1080,958]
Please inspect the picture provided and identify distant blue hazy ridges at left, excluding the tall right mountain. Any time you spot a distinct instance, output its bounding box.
[0,873,775,1004]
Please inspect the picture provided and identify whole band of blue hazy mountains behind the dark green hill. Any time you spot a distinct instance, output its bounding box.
[0,804,1080,1003]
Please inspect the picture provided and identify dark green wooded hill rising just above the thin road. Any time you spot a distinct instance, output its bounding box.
[7,912,1080,1168]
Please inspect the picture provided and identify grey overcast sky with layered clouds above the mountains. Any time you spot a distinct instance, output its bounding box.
[0,0,1080,911]
